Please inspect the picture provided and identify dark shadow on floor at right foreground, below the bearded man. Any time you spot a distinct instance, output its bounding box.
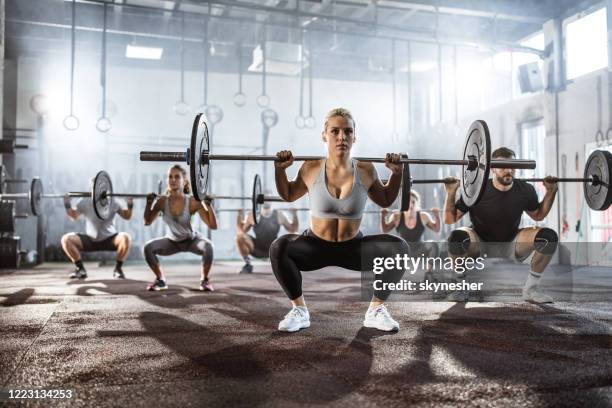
[389,303,612,405]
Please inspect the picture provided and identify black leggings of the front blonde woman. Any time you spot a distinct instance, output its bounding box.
[270,230,410,300]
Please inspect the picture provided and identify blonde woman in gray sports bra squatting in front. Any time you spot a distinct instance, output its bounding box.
[270,108,409,332]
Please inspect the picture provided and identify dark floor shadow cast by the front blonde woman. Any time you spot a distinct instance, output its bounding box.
[98,310,388,406]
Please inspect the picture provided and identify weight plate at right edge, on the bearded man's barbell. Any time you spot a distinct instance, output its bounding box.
[583,150,612,211]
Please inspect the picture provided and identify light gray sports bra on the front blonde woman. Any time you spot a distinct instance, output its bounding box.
[308,159,368,220]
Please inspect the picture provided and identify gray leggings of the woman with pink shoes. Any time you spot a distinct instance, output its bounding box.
[144,237,213,268]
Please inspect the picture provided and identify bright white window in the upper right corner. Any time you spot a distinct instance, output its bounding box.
[565,7,608,79]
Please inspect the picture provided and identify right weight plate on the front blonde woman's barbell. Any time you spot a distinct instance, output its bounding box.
[461,120,491,207]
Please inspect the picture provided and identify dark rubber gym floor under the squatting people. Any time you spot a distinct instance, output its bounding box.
[0,263,612,408]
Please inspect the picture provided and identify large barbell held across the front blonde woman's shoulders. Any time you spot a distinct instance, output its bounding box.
[140,113,536,211]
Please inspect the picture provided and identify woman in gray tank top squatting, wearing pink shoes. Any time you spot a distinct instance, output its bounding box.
[144,164,217,291]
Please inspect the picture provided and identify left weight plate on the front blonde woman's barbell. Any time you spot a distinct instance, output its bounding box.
[189,113,210,201]
